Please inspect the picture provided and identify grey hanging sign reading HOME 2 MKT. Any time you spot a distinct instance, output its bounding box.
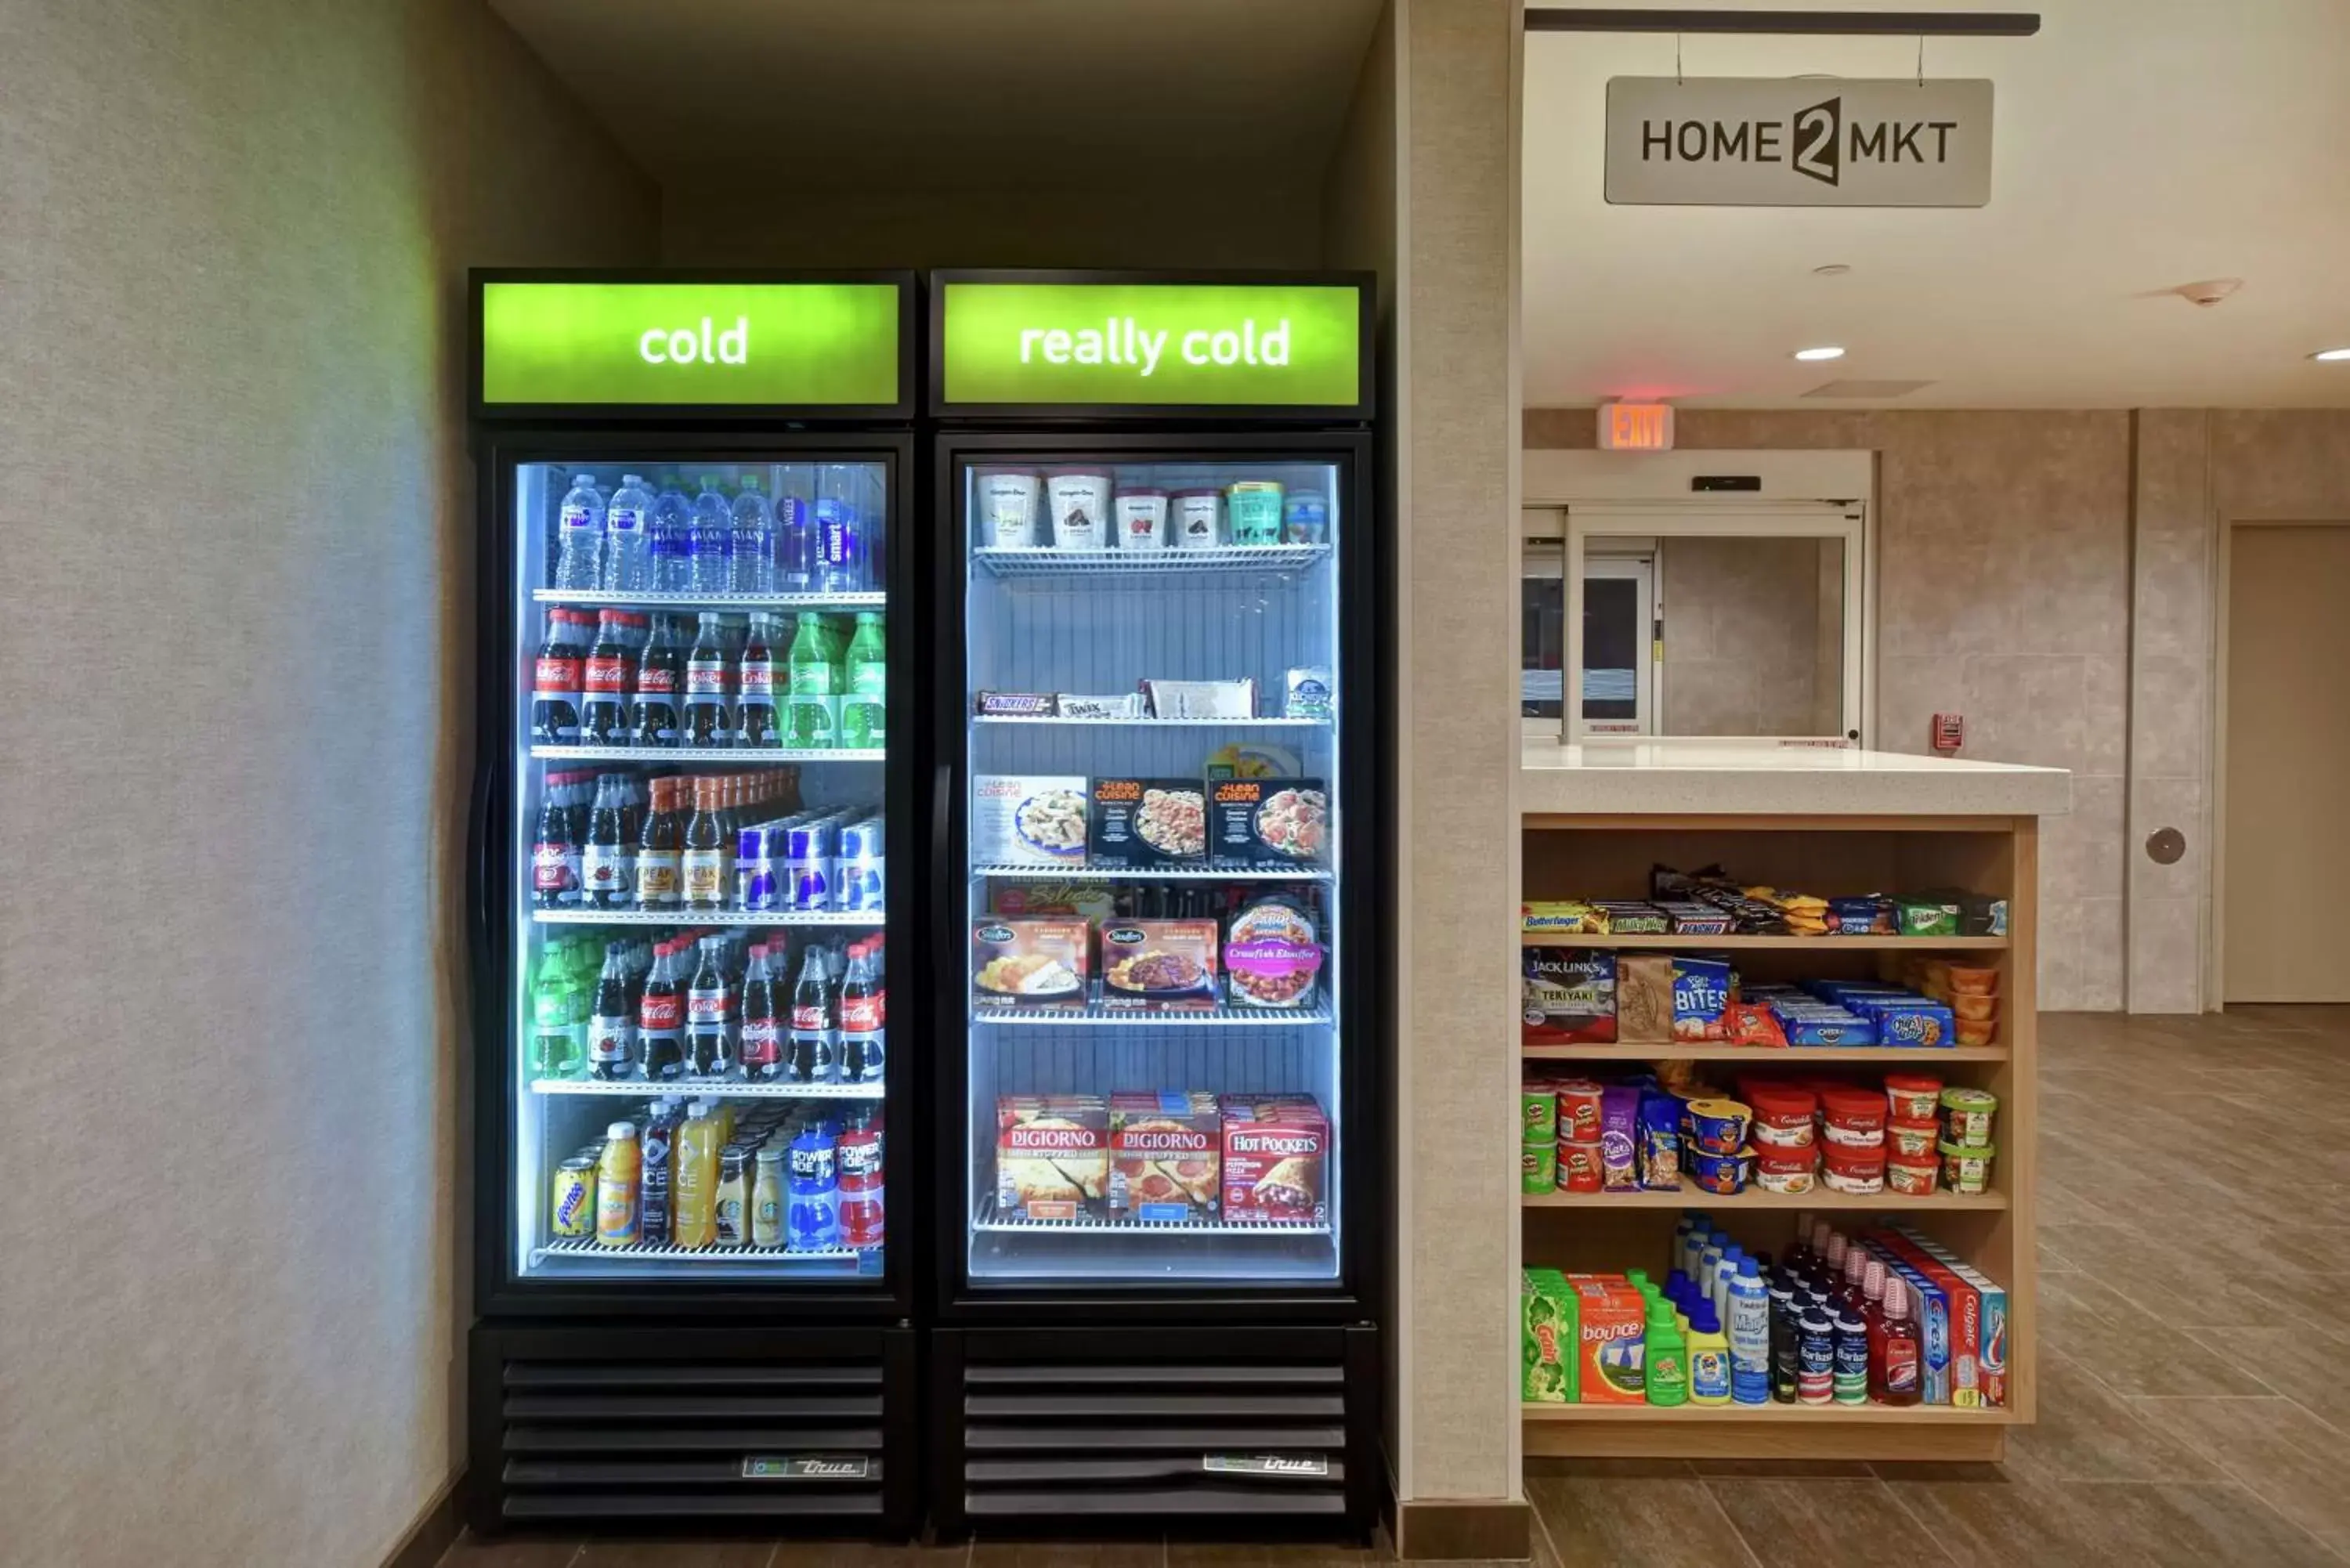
[1607,75,1990,207]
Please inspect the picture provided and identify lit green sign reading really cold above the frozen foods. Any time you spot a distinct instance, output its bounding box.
[942,282,1363,406]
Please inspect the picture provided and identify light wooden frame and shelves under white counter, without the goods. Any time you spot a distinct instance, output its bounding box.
[1520,814,2040,1460]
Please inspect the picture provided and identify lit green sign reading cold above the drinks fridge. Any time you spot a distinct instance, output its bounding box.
[482,282,900,406]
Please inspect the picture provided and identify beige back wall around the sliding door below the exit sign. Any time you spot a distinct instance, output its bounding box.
[1525,409,2131,1011]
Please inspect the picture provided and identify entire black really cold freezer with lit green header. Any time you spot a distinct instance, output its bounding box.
[928,273,1384,1533]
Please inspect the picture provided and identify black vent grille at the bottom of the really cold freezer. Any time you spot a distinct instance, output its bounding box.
[961,1357,1349,1533]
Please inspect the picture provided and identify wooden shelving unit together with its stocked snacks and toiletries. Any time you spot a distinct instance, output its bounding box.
[1518,818,2037,1460]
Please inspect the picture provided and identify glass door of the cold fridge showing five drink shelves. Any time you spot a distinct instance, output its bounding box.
[503,453,893,1286]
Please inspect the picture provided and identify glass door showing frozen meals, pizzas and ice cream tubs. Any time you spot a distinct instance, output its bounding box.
[947,446,1358,1291]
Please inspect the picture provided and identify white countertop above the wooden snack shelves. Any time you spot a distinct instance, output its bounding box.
[1518,740,2073,816]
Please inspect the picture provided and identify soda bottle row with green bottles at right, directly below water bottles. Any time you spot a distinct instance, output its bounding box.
[531,609,888,750]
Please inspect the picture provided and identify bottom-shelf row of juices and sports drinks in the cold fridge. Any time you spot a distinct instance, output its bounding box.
[548,1096,884,1253]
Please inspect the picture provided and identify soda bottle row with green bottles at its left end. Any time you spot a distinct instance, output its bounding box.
[529,927,888,1091]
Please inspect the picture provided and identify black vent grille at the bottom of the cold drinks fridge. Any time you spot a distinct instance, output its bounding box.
[498,1357,884,1533]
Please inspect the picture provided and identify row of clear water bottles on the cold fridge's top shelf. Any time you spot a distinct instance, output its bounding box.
[550,463,886,592]
